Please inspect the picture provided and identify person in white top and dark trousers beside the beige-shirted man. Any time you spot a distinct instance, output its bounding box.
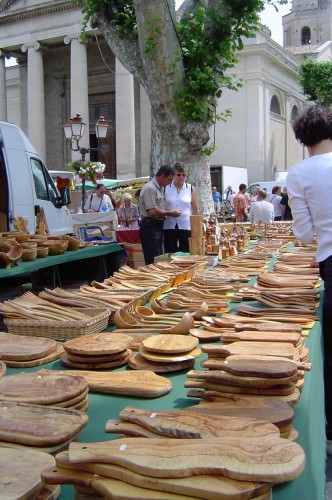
[164,163,199,253]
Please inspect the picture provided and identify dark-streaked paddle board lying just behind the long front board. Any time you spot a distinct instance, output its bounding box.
[119,406,280,439]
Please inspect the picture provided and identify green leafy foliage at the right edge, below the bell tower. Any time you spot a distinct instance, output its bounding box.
[299,59,332,107]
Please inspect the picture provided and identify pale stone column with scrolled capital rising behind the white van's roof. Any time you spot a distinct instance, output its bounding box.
[21,42,46,161]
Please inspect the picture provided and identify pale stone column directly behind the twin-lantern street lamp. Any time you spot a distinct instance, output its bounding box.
[64,33,90,160]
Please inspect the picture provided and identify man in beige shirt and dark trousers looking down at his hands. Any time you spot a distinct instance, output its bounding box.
[138,165,181,264]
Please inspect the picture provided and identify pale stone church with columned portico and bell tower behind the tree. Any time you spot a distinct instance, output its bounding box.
[0,0,332,182]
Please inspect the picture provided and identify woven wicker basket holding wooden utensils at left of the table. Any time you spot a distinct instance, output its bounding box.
[4,307,109,342]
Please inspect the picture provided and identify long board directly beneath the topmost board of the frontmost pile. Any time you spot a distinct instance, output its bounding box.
[49,452,271,500]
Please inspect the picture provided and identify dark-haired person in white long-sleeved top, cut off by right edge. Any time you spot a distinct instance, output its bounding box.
[286,106,332,455]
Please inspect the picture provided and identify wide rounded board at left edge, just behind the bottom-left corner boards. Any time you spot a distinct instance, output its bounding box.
[0,401,88,446]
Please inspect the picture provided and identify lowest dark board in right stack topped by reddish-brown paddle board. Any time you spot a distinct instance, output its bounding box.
[187,387,301,406]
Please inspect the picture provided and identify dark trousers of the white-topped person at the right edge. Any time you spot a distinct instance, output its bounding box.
[319,255,332,439]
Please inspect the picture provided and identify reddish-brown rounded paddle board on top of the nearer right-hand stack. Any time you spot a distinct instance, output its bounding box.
[201,356,298,379]
